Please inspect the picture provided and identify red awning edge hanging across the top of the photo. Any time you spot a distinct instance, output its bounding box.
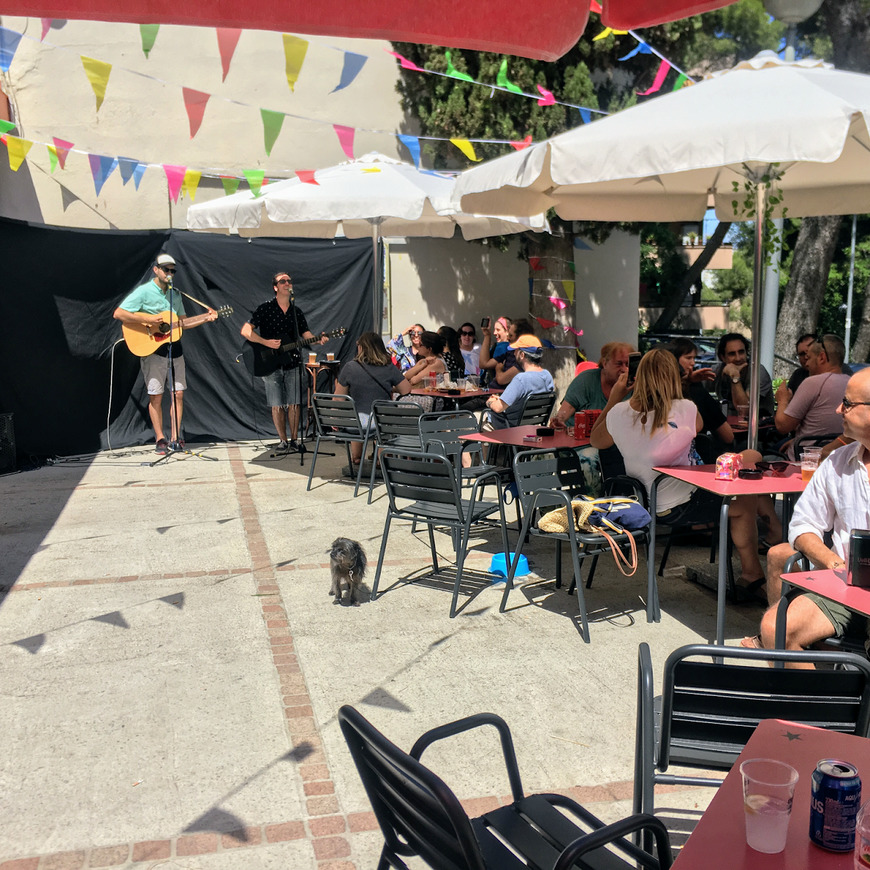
[3,0,733,60]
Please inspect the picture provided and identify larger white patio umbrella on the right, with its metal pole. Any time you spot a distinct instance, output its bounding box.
[456,52,870,444]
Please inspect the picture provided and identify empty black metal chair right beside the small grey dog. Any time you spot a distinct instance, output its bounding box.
[371,448,510,619]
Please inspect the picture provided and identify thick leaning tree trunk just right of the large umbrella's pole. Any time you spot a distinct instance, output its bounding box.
[776,215,843,377]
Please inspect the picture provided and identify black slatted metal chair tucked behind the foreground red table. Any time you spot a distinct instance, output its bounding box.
[633,643,870,836]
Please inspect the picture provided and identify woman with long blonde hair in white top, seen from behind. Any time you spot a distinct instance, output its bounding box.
[591,348,764,586]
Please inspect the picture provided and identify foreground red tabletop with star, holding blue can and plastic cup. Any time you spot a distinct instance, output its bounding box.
[674,719,870,870]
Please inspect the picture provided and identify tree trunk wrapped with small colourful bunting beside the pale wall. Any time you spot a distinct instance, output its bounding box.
[526,226,579,396]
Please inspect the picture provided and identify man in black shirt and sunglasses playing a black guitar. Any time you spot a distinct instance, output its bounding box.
[241,272,329,453]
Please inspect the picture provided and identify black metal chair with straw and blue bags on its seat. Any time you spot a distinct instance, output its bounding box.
[499,448,658,643]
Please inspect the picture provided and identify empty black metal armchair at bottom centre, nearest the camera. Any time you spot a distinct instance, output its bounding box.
[338,705,672,870]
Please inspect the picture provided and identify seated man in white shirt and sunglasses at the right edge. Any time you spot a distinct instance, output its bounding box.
[744,369,870,664]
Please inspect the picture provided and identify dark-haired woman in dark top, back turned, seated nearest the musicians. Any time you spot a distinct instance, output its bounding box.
[335,332,411,465]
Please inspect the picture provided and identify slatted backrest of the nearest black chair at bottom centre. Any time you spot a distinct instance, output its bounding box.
[338,705,485,870]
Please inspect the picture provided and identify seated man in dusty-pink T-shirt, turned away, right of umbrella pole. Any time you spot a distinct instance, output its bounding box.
[776,335,849,459]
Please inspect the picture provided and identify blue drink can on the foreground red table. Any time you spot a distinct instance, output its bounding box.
[810,758,861,852]
